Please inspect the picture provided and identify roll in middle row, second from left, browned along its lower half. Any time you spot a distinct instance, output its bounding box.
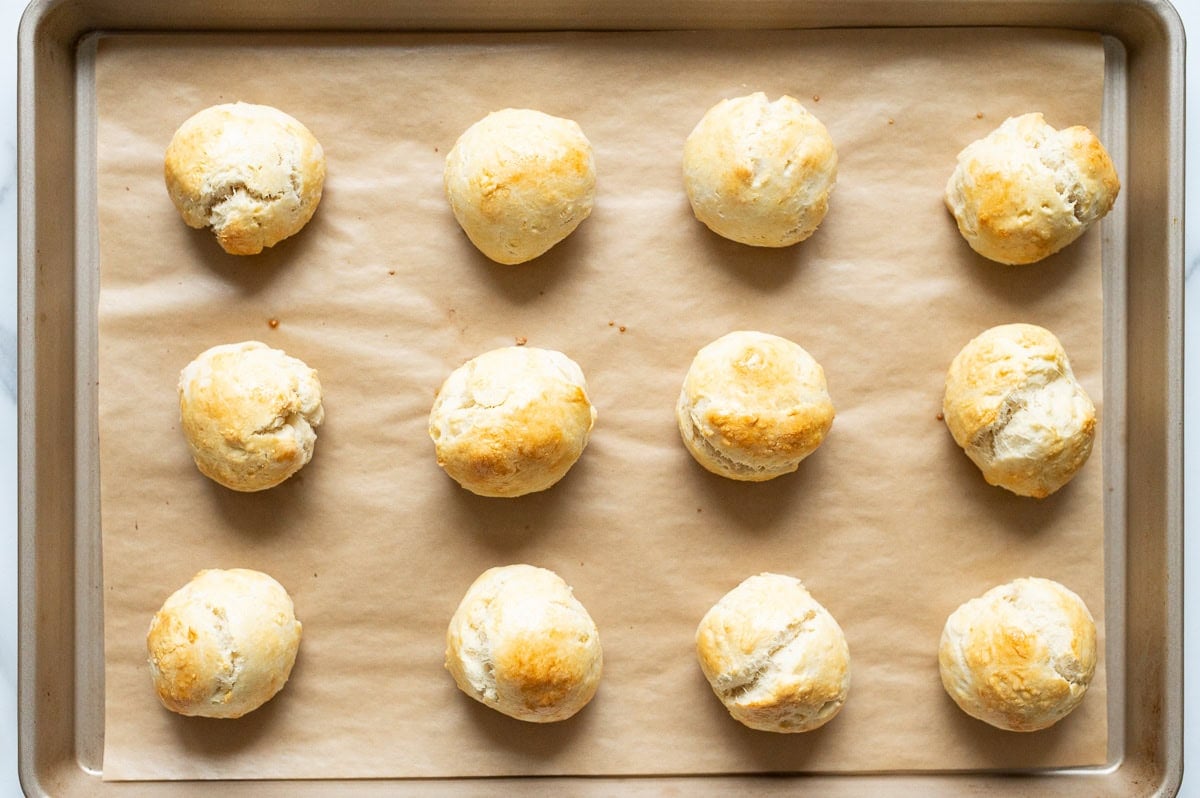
[430,347,596,497]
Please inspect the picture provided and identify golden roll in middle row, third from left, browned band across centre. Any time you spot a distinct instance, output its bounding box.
[676,330,834,482]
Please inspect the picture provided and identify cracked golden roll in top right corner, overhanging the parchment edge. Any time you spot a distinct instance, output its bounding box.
[946,114,1121,264]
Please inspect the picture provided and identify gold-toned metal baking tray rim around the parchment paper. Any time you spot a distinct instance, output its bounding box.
[18,0,1184,796]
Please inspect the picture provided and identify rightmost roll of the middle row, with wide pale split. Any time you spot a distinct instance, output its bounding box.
[942,324,1096,499]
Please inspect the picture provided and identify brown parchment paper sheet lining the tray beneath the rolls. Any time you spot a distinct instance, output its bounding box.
[96,30,1106,779]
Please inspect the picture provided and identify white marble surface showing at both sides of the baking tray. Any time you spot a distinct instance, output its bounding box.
[0,0,1200,798]
